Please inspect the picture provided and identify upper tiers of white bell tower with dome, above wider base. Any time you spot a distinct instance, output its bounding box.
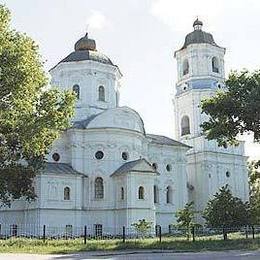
[174,19,225,144]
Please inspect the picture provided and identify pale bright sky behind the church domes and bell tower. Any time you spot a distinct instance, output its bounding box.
[0,0,260,159]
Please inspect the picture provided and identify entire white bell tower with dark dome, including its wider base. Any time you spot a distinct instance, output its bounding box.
[174,19,248,222]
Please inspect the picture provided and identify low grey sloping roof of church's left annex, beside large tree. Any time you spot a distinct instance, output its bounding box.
[42,162,84,175]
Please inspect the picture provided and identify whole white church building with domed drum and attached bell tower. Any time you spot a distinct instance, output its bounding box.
[0,19,249,235]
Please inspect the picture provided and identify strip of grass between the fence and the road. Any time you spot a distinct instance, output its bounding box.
[0,235,260,254]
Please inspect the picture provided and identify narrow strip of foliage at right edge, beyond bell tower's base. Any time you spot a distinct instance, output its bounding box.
[248,161,260,225]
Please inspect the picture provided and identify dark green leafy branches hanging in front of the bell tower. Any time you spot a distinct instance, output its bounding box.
[201,70,260,147]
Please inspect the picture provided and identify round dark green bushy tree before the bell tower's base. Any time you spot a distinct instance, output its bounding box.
[203,185,249,239]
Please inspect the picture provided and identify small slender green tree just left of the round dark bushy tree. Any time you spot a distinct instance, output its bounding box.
[175,201,198,240]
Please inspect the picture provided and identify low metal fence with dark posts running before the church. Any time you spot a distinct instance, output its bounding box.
[0,224,260,243]
